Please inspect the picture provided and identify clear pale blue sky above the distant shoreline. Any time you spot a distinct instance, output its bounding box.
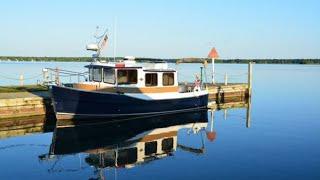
[0,0,320,58]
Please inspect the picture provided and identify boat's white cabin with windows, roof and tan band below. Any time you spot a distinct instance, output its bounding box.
[73,56,188,93]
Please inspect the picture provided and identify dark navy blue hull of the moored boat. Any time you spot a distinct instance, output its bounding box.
[51,86,208,119]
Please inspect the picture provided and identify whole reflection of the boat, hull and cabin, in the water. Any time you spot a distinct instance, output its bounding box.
[39,110,208,176]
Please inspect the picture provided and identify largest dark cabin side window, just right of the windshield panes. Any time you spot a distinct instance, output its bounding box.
[117,69,138,84]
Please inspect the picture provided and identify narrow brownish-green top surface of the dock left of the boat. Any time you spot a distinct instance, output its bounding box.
[0,85,48,93]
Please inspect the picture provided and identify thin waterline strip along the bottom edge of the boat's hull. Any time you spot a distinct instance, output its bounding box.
[56,106,207,120]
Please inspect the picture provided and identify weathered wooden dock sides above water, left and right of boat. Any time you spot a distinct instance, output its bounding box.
[0,84,249,121]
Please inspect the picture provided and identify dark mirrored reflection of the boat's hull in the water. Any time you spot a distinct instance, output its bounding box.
[51,110,208,155]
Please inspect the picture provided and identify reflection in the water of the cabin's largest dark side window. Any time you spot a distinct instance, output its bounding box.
[117,147,138,165]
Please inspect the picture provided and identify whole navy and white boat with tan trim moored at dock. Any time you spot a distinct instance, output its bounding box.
[51,30,208,120]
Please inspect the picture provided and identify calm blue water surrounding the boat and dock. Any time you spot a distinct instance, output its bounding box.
[0,62,320,179]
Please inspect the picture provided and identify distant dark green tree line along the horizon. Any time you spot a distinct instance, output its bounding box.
[0,56,320,64]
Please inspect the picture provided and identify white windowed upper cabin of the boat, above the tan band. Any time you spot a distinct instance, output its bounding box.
[86,61,177,87]
